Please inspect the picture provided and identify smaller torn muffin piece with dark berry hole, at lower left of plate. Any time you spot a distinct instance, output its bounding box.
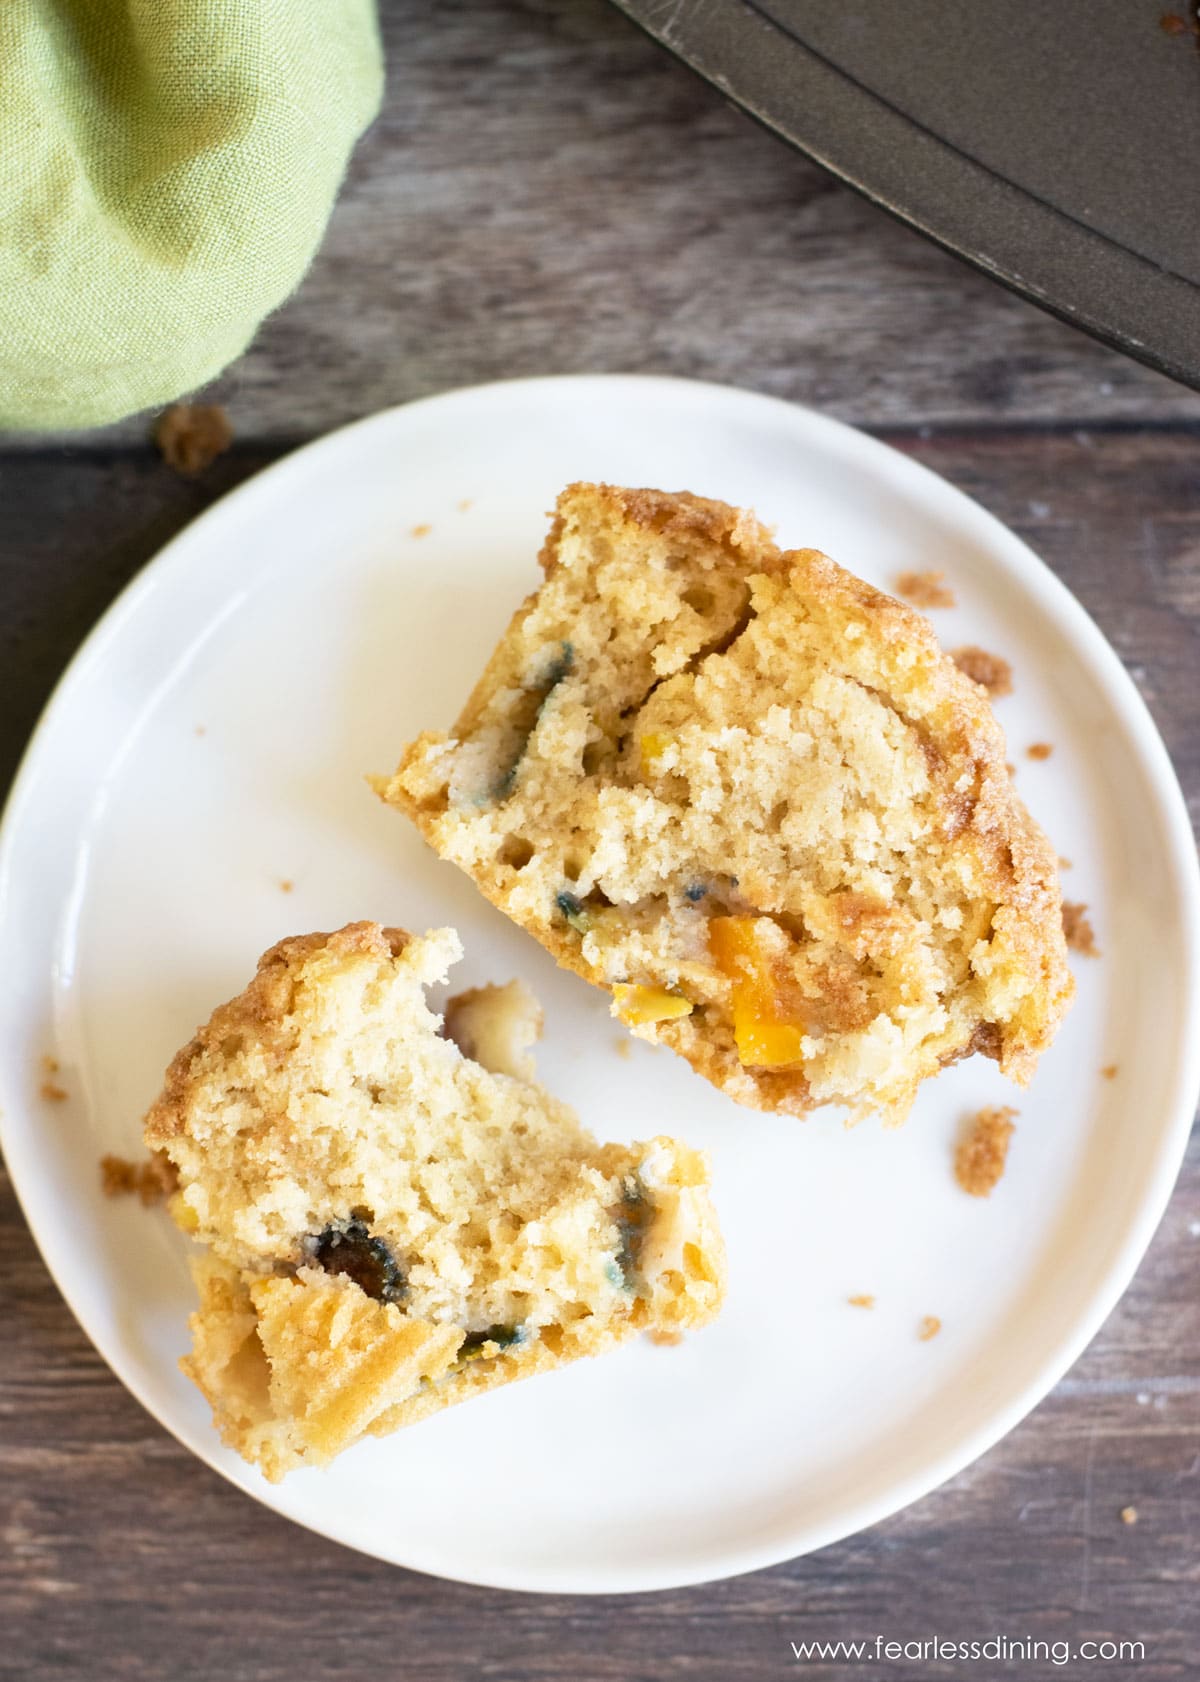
[145,923,724,1475]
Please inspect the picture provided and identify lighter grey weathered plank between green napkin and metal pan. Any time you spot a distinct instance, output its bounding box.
[9,0,1200,442]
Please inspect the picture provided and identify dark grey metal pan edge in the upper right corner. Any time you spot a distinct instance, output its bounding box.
[616,0,1200,387]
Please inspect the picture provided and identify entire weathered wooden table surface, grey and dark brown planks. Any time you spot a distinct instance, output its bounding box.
[0,0,1200,1682]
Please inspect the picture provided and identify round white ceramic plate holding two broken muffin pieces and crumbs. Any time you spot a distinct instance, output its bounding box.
[0,378,1200,1591]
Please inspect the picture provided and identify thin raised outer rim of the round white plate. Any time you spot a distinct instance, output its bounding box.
[0,373,1200,1595]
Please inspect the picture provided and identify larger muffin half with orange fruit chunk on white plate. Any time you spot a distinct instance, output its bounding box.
[379,484,1070,1120]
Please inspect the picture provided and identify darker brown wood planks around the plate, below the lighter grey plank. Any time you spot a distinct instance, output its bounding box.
[0,427,1200,1682]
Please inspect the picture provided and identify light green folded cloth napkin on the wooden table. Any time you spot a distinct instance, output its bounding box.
[0,0,382,429]
